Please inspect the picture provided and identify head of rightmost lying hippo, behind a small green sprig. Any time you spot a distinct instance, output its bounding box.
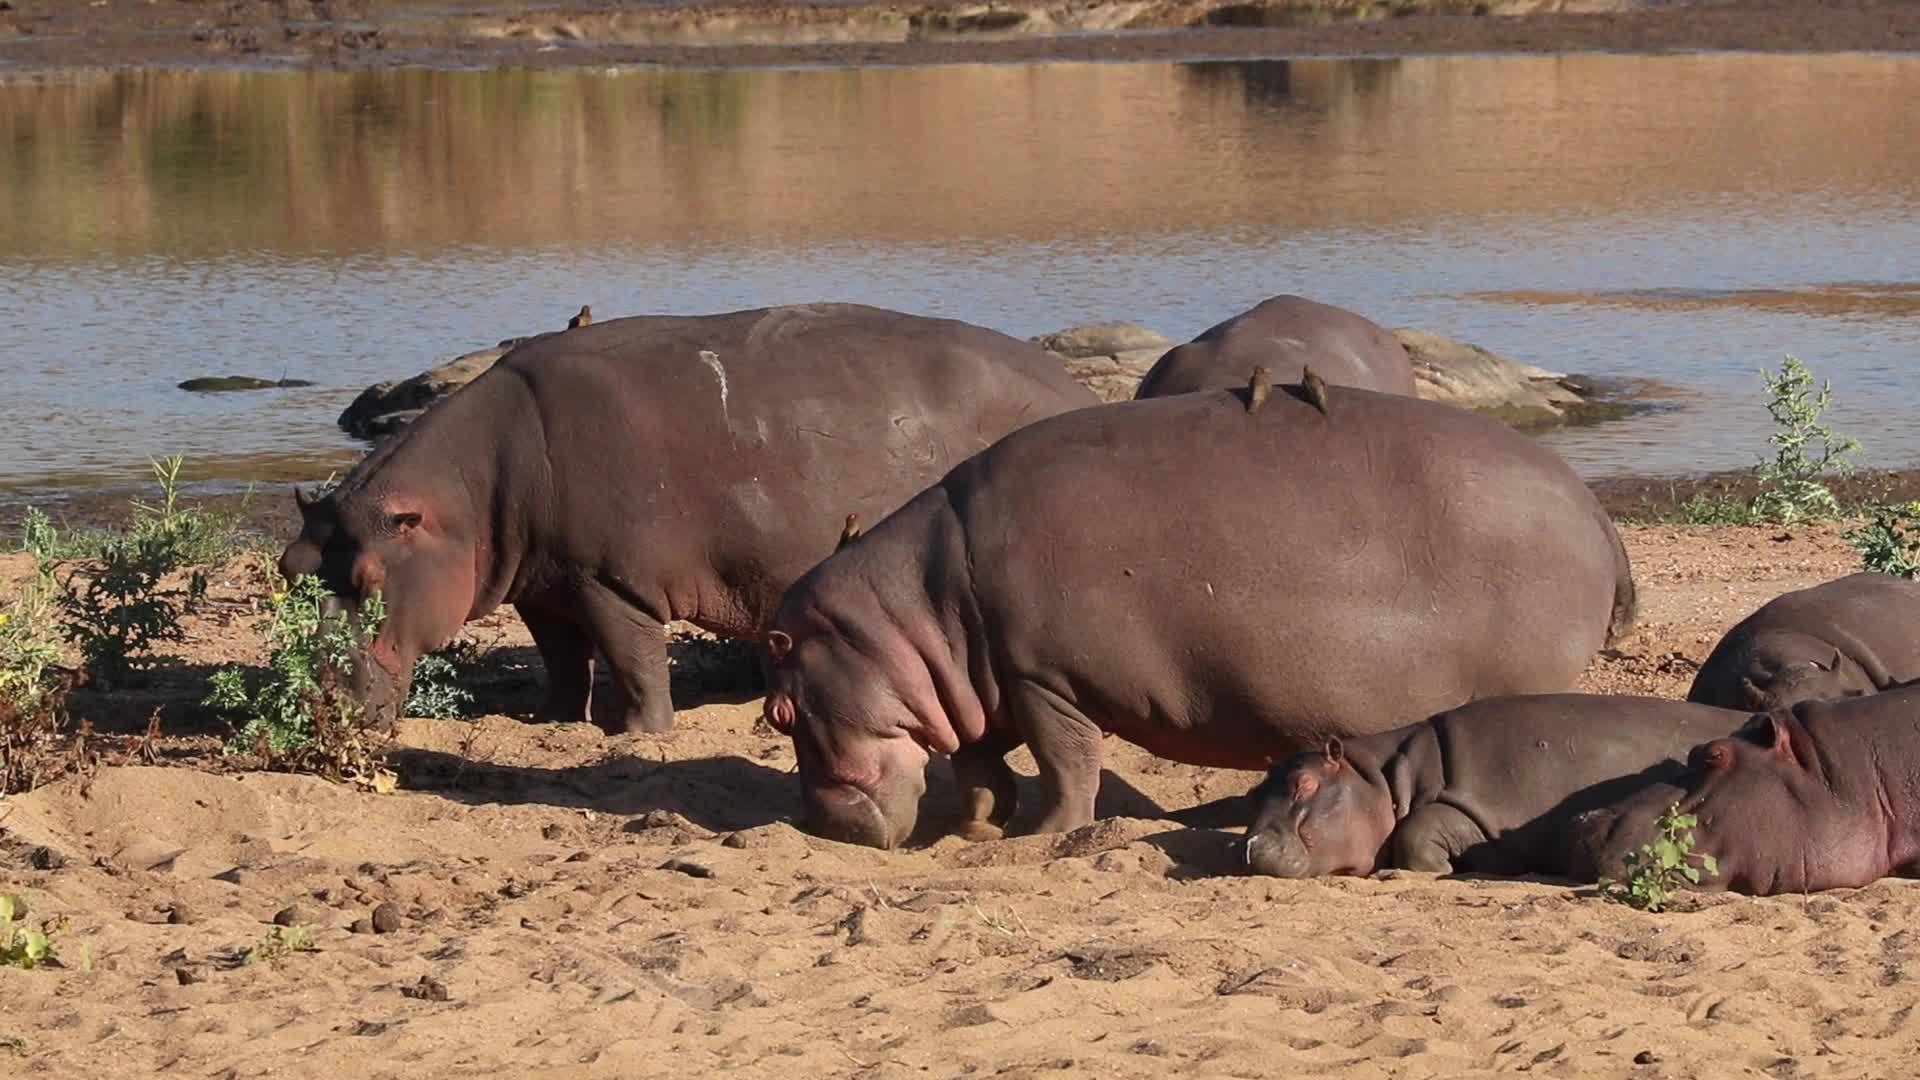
[1571,709,1884,896]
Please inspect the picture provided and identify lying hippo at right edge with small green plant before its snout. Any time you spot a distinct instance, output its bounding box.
[1571,686,1920,896]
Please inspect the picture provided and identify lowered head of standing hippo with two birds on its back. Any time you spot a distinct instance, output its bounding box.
[764,628,958,847]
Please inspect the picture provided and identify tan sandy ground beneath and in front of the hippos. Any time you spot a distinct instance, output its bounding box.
[0,527,1920,1080]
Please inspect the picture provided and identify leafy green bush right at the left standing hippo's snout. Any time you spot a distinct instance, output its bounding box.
[205,575,394,790]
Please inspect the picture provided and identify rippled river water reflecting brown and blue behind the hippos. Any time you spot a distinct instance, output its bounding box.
[0,56,1920,490]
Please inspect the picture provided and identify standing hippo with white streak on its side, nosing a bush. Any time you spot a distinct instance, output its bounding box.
[280,304,1098,732]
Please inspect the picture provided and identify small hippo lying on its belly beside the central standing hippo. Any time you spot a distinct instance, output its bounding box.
[1244,694,1747,878]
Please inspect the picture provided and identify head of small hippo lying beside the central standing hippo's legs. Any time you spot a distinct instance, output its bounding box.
[1244,738,1394,878]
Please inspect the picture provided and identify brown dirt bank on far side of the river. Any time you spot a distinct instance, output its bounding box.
[11,0,1920,73]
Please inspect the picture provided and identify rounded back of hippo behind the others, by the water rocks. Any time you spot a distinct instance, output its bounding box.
[1133,296,1413,400]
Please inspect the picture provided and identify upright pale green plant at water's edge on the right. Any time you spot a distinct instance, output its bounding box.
[1753,356,1860,525]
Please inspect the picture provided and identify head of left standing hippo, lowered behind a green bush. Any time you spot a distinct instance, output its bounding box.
[280,486,474,721]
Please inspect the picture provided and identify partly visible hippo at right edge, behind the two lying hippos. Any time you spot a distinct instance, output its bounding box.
[1686,573,1920,713]
